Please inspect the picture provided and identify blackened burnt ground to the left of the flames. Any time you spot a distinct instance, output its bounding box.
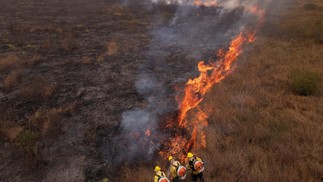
[0,0,260,181]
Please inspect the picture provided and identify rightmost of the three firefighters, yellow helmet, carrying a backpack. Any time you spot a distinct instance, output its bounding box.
[186,152,204,182]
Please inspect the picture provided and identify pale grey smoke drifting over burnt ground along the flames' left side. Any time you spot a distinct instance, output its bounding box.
[109,0,292,160]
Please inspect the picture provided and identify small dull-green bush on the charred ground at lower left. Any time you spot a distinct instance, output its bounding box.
[15,129,39,153]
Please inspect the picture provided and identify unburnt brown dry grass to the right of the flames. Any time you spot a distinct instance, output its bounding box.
[200,1,323,181]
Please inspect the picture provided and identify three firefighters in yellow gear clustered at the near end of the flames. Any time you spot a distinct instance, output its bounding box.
[154,152,204,182]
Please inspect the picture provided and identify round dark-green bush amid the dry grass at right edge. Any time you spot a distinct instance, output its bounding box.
[289,70,321,96]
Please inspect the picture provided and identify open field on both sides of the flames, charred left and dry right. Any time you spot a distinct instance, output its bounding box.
[0,0,323,182]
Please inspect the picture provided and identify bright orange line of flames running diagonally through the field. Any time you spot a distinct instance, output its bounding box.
[160,4,265,161]
